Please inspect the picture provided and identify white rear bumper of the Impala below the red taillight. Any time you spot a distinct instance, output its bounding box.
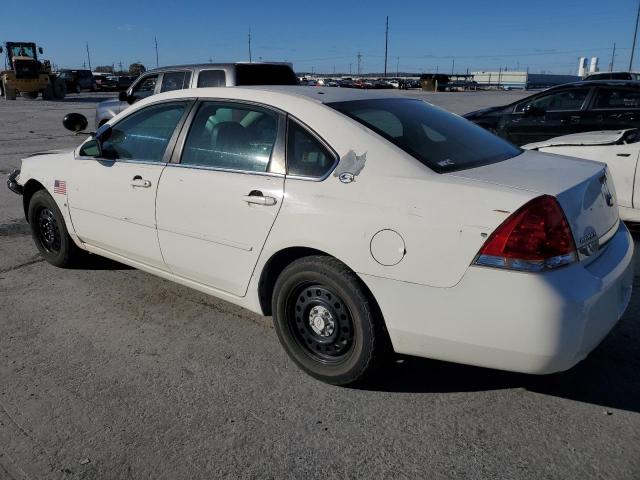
[361,222,633,374]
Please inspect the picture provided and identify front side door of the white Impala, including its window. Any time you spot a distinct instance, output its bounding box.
[67,101,191,268]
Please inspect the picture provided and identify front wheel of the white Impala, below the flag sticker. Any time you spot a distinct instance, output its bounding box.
[29,190,84,267]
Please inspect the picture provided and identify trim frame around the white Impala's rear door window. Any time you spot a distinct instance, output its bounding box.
[168,98,286,176]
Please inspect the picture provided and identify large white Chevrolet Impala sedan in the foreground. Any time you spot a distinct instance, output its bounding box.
[9,87,633,384]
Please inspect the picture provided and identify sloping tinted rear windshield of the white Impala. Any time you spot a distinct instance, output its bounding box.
[328,98,522,173]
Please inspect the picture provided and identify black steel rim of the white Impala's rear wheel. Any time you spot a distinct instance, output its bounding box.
[287,284,355,363]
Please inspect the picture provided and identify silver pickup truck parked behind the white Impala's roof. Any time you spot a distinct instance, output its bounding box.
[95,62,298,128]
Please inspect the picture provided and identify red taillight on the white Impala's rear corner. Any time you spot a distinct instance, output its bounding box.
[474,195,578,272]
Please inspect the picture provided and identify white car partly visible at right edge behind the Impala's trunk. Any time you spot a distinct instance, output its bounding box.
[522,129,640,222]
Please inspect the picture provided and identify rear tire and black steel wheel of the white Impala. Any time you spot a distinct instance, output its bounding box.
[272,256,390,385]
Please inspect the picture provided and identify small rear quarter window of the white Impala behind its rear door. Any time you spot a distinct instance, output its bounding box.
[287,121,336,178]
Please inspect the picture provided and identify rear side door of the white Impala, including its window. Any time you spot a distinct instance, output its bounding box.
[156,101,284,296]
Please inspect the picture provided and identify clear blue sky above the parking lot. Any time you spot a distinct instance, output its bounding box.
[0,0,640,73]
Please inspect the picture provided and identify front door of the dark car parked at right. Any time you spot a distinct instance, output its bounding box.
[497,87,591,145]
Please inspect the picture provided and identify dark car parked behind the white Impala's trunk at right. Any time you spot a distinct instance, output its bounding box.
[464,80,640,145]
